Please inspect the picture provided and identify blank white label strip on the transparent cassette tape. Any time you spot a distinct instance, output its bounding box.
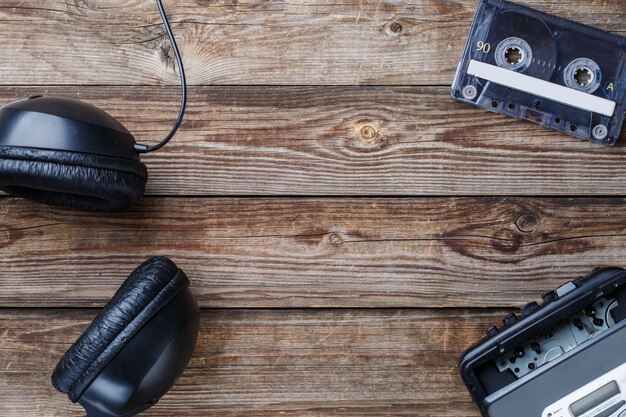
[467,60,617,117]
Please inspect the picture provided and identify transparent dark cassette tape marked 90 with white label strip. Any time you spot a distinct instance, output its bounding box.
[452,0,626,146]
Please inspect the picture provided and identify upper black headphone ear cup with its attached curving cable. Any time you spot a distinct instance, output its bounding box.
[0,0,187,211]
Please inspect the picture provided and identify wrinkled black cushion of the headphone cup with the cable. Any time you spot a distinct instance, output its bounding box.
[0,147,148,211]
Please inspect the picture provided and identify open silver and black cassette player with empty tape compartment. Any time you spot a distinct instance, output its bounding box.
[460,268,626,417]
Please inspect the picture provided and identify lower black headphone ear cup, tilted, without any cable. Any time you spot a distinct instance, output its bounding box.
[52,257,199,417]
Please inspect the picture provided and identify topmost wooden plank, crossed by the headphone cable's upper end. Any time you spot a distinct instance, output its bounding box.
[0,0,626,85]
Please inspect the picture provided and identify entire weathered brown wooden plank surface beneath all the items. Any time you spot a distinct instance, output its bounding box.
[0,0,626,417]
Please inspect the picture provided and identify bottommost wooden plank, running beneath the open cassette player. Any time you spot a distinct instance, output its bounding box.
[0,310,504,417]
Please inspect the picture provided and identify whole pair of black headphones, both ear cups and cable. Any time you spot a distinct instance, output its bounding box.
[0,0,199,417]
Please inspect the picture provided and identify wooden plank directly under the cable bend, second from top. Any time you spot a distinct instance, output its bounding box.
[0,87,626,196]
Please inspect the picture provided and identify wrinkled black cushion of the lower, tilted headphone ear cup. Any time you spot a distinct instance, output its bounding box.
[52,257,189,402]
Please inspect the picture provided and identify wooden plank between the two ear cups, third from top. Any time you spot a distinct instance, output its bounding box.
[0,198,626,308]
